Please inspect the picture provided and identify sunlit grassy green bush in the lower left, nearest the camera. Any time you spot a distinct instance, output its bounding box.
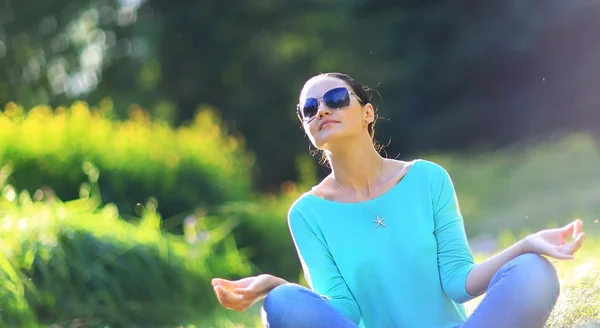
[0,172,250,327]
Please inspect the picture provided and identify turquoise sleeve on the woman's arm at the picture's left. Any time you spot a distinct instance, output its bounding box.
[288,206,361,325]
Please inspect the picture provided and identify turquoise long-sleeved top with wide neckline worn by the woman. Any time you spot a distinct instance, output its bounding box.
[288,159,475,328]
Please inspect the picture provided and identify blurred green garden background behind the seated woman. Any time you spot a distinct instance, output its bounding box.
[0,0,600,327]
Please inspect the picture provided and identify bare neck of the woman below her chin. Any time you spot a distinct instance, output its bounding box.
[328,134,384,195]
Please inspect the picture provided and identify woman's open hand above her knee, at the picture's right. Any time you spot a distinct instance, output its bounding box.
[523,219,585,260]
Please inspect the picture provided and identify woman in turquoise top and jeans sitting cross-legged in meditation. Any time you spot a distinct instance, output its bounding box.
[213,73,584,328]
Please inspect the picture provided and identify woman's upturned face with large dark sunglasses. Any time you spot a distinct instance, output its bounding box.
[299,75,374,149]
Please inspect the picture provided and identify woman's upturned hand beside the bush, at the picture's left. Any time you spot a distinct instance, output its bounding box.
[212,274,285,312]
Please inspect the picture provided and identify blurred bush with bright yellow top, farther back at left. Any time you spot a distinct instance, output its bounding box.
[0,101,253,223]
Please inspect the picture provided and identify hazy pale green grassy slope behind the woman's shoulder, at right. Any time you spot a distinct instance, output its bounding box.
[424,134,600,236]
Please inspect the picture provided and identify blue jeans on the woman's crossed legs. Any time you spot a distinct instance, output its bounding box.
[262,254,560,328]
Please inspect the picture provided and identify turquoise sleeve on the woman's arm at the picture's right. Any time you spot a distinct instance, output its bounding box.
[431,165,475,303]
